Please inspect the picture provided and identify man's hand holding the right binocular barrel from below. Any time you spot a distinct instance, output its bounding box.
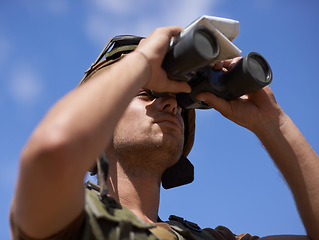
[197,58,285,133]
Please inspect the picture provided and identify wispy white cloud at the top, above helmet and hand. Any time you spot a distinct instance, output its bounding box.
[85,0,220,47]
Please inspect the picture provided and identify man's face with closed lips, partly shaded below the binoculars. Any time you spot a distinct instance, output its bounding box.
[113,90,184,169]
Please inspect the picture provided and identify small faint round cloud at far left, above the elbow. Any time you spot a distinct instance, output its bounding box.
[10,63,43,105]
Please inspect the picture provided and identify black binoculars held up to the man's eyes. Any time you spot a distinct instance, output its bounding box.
[162,19,272,109]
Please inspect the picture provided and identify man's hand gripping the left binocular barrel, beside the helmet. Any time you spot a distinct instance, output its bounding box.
[135,27,191,93]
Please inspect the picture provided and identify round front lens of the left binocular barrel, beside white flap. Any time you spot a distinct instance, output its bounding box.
[194,29,218,59]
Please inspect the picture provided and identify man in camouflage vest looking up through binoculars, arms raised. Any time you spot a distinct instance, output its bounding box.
[11,27,319,240]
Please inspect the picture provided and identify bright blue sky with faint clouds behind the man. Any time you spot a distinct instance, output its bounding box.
[0,0,319,239]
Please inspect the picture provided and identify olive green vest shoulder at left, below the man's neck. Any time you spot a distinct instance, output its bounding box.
[83,183,156,240]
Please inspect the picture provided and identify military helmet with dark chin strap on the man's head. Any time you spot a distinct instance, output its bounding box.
[79,35,195,189]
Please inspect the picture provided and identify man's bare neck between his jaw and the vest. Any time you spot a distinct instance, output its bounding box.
[107,159,160,223]
